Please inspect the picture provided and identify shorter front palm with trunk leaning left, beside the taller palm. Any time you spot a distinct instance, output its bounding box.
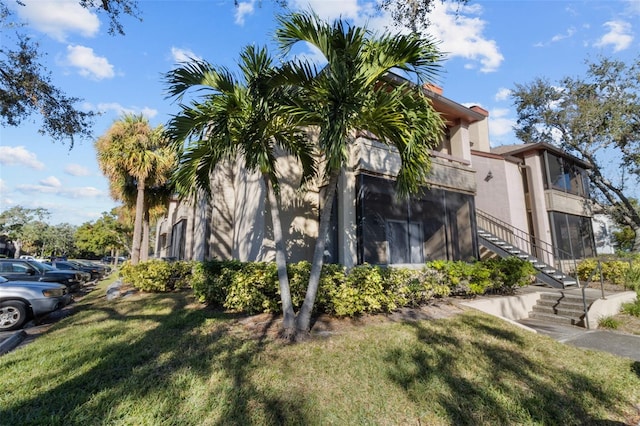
[166,46,315,337]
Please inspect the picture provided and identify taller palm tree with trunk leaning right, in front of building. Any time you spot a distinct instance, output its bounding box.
[276,13,444,332]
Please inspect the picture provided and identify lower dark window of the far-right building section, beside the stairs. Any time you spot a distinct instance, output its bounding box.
[549,212,595,260]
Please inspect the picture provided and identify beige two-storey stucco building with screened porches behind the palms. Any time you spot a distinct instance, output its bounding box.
[156,77,594,290]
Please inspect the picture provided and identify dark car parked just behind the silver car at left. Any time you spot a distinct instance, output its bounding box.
[0,259,83,291]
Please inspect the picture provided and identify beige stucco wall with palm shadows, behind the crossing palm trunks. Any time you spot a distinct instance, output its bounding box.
[208,156,318,262]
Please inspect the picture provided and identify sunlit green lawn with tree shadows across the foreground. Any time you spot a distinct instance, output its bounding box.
[0,282,640,425]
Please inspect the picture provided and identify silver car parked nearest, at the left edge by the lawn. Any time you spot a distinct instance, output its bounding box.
[0,277,72,331]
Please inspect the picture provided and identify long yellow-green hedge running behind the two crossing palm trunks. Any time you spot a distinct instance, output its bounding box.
[186,259,535,317]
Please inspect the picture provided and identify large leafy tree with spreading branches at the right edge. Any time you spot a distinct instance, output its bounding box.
[512,58,640,251]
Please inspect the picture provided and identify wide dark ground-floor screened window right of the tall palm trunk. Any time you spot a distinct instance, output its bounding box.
[357,175,477,265]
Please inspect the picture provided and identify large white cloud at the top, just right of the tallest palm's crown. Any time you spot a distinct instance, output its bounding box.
[429,2,504,73]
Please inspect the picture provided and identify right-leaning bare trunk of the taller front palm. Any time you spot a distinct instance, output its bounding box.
[296,169,340,333]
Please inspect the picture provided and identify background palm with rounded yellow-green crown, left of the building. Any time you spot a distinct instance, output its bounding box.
[95,114,176,265]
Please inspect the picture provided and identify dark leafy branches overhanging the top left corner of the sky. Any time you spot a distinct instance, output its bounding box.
[0,0,138,143]
